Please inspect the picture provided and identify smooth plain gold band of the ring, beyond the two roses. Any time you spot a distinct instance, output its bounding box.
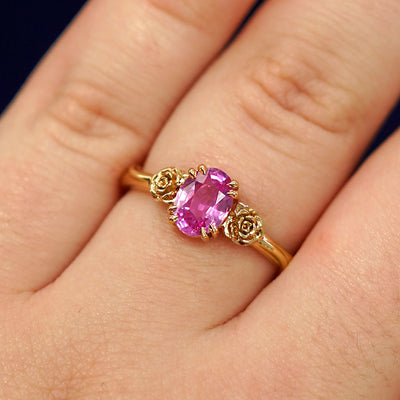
[121,166,292,271]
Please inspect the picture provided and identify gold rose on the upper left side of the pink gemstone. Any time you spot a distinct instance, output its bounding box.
[150,168,183,203]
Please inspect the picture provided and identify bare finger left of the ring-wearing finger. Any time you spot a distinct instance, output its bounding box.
[0,0,252,291]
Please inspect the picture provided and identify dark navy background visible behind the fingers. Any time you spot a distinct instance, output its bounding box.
[0,0,400,157]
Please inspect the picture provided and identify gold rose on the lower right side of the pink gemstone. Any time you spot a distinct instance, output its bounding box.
[224,203,263,245]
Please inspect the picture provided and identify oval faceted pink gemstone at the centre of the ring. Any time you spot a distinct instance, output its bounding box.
[174,168,233,236]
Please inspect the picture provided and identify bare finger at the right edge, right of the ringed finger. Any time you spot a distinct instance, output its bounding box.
[238,131,400,400]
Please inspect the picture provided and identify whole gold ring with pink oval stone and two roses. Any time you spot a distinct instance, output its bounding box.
[122,164,292,270]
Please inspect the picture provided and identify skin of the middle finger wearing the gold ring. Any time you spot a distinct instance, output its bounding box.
[71,0,400,328]
